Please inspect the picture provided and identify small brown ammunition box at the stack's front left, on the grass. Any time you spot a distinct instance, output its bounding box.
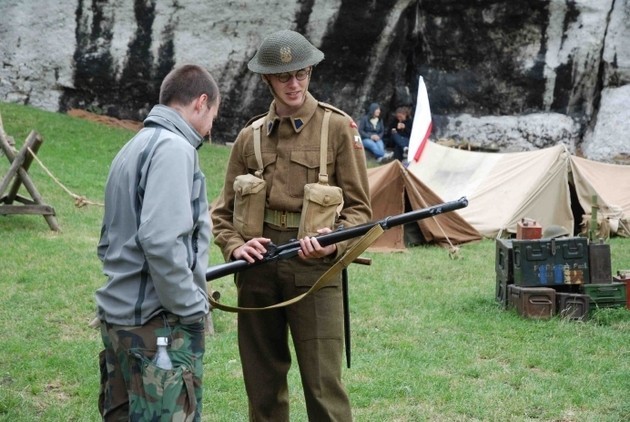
[508,284,556,319]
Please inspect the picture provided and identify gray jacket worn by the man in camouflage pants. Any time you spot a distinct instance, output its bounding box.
[96,105,210,325]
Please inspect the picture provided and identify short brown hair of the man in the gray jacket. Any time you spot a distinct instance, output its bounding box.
[160,64,219,106]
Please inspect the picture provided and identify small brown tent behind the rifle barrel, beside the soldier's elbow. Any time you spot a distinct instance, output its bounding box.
[368,161,481,250]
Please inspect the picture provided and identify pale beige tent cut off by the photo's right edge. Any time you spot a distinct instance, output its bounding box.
[571,156,630,236]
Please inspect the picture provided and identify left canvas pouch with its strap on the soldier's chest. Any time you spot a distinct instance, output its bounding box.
[232,118,267,241]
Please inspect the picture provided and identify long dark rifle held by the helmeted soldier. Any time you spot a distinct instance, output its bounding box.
[206,197,468,281]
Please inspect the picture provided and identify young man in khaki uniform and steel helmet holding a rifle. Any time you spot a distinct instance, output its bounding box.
[212,30,371,422]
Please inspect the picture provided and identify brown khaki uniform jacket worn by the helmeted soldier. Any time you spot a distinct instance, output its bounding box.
[212,93,372,261]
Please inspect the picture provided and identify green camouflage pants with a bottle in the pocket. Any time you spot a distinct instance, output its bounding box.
[99,314,205,422]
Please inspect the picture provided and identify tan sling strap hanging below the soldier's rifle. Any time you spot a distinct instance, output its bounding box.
[208,224,384,312]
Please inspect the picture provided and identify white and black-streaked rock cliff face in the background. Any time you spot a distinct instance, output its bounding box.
[0,0,630,163]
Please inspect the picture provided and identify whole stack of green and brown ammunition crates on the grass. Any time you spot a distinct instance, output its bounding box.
[495,232,630,320]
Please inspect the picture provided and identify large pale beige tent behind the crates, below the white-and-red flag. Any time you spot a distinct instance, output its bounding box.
[408,142,574,237]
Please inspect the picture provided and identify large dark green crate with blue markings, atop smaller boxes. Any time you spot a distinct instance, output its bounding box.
[512,237,590,287]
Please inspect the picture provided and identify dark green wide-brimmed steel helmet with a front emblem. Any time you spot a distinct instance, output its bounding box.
[247,29,324,75]
